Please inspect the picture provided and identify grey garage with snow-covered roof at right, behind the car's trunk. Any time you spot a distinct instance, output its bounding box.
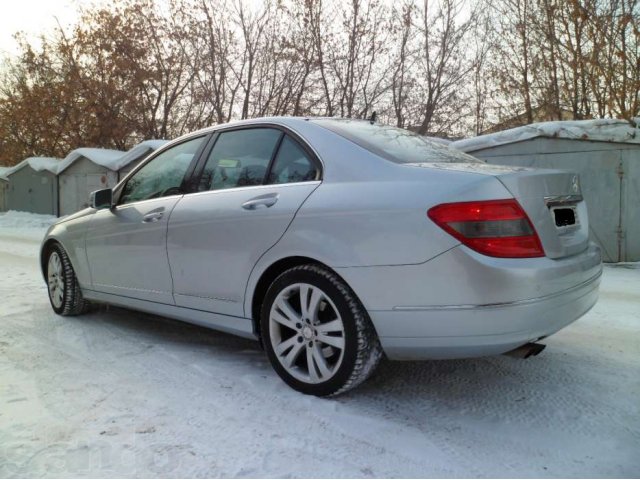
[451,119,640,262]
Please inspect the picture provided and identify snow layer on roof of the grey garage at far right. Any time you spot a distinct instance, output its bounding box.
[449,119,640,152]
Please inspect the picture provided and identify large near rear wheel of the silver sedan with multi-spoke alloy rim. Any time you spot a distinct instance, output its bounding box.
[261,265,382,396]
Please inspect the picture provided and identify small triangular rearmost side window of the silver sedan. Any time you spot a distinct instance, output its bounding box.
[268,136,319,184]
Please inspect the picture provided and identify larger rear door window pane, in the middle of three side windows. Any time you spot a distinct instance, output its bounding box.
[198,128,282,191]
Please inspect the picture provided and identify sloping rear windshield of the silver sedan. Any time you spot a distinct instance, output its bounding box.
[314,118,484,163]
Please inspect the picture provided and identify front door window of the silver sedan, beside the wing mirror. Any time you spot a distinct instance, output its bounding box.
[119,137,205,204]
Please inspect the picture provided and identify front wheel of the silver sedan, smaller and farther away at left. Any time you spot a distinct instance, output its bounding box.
[47,244,88,315]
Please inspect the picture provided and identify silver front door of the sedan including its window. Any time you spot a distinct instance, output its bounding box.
[86,137,205,304]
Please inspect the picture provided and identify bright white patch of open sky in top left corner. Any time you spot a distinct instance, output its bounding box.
[0,0,104,55]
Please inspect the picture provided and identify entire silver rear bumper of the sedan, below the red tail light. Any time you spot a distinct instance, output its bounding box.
[339,245,602,360]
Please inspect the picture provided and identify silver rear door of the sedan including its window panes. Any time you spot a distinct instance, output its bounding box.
[167,127,321,317]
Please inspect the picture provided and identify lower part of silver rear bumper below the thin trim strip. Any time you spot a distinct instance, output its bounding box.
[370,272,601,360]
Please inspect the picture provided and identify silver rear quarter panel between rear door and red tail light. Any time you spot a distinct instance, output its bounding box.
[245,166,511,312]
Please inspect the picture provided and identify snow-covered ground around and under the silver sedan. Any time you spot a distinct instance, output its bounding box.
[0,213,640,477]
